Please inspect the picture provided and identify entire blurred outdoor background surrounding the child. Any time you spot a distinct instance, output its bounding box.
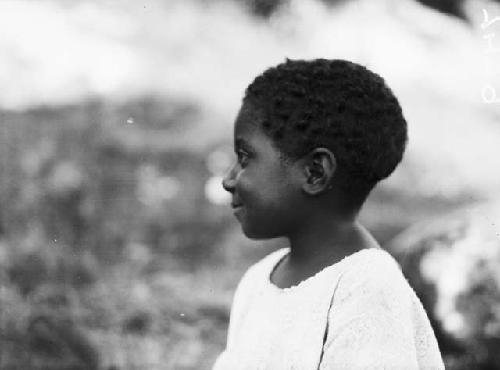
[0,0,500,370]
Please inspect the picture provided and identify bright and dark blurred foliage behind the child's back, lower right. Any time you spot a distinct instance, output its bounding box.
[391,204,500,370]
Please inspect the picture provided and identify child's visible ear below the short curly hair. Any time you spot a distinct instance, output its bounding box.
[302,148,337,195]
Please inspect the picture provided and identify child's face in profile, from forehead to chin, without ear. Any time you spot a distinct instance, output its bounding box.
[223,103,301,239]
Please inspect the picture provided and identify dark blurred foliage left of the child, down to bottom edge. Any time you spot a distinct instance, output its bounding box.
[0,97,239,370]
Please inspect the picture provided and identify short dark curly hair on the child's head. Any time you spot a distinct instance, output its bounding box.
[243,59,408,201]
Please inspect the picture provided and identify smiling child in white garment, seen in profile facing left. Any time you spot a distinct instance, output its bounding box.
[214,59,444,370]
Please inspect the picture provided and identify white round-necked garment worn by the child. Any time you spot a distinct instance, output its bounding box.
[213,248,444,370]
